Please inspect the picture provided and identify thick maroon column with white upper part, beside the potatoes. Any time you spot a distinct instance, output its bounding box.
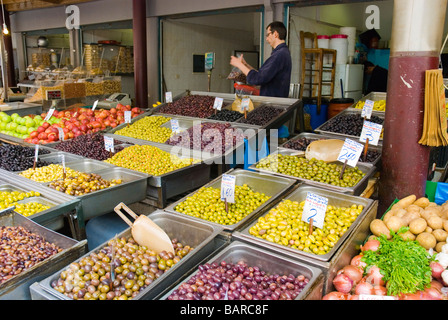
[378,0,447,216]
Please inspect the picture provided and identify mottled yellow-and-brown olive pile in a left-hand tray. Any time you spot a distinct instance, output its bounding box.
[48,173,122,196]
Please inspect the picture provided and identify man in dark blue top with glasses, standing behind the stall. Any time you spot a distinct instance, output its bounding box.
[230,21,292,98]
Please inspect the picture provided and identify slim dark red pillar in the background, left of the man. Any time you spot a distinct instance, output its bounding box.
[132,0,148,109]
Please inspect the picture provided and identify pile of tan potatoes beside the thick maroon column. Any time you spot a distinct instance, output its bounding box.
[370,195,448,252]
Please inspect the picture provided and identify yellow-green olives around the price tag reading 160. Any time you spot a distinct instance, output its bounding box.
[174,184,270,225]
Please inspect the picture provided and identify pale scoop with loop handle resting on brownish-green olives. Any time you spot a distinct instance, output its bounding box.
[114,202,174,254]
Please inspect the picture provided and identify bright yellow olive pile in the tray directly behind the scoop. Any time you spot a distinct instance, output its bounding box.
[105,145,194,176]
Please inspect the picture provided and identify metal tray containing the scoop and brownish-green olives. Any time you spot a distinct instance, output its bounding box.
[32,210,225,300]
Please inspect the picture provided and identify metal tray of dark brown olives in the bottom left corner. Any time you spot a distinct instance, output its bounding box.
[0,211,87,300]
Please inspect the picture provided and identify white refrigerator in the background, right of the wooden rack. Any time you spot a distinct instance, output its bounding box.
[333,64,364,102]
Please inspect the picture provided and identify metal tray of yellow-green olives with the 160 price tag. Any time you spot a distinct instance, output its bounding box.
[165,169,295,231]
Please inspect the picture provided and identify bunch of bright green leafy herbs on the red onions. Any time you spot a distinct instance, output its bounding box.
[362,227,435,295]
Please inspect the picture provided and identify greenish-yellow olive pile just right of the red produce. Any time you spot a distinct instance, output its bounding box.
[115,116,172,143]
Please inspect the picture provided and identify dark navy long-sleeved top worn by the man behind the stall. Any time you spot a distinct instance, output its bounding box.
[247,43,292,98]
